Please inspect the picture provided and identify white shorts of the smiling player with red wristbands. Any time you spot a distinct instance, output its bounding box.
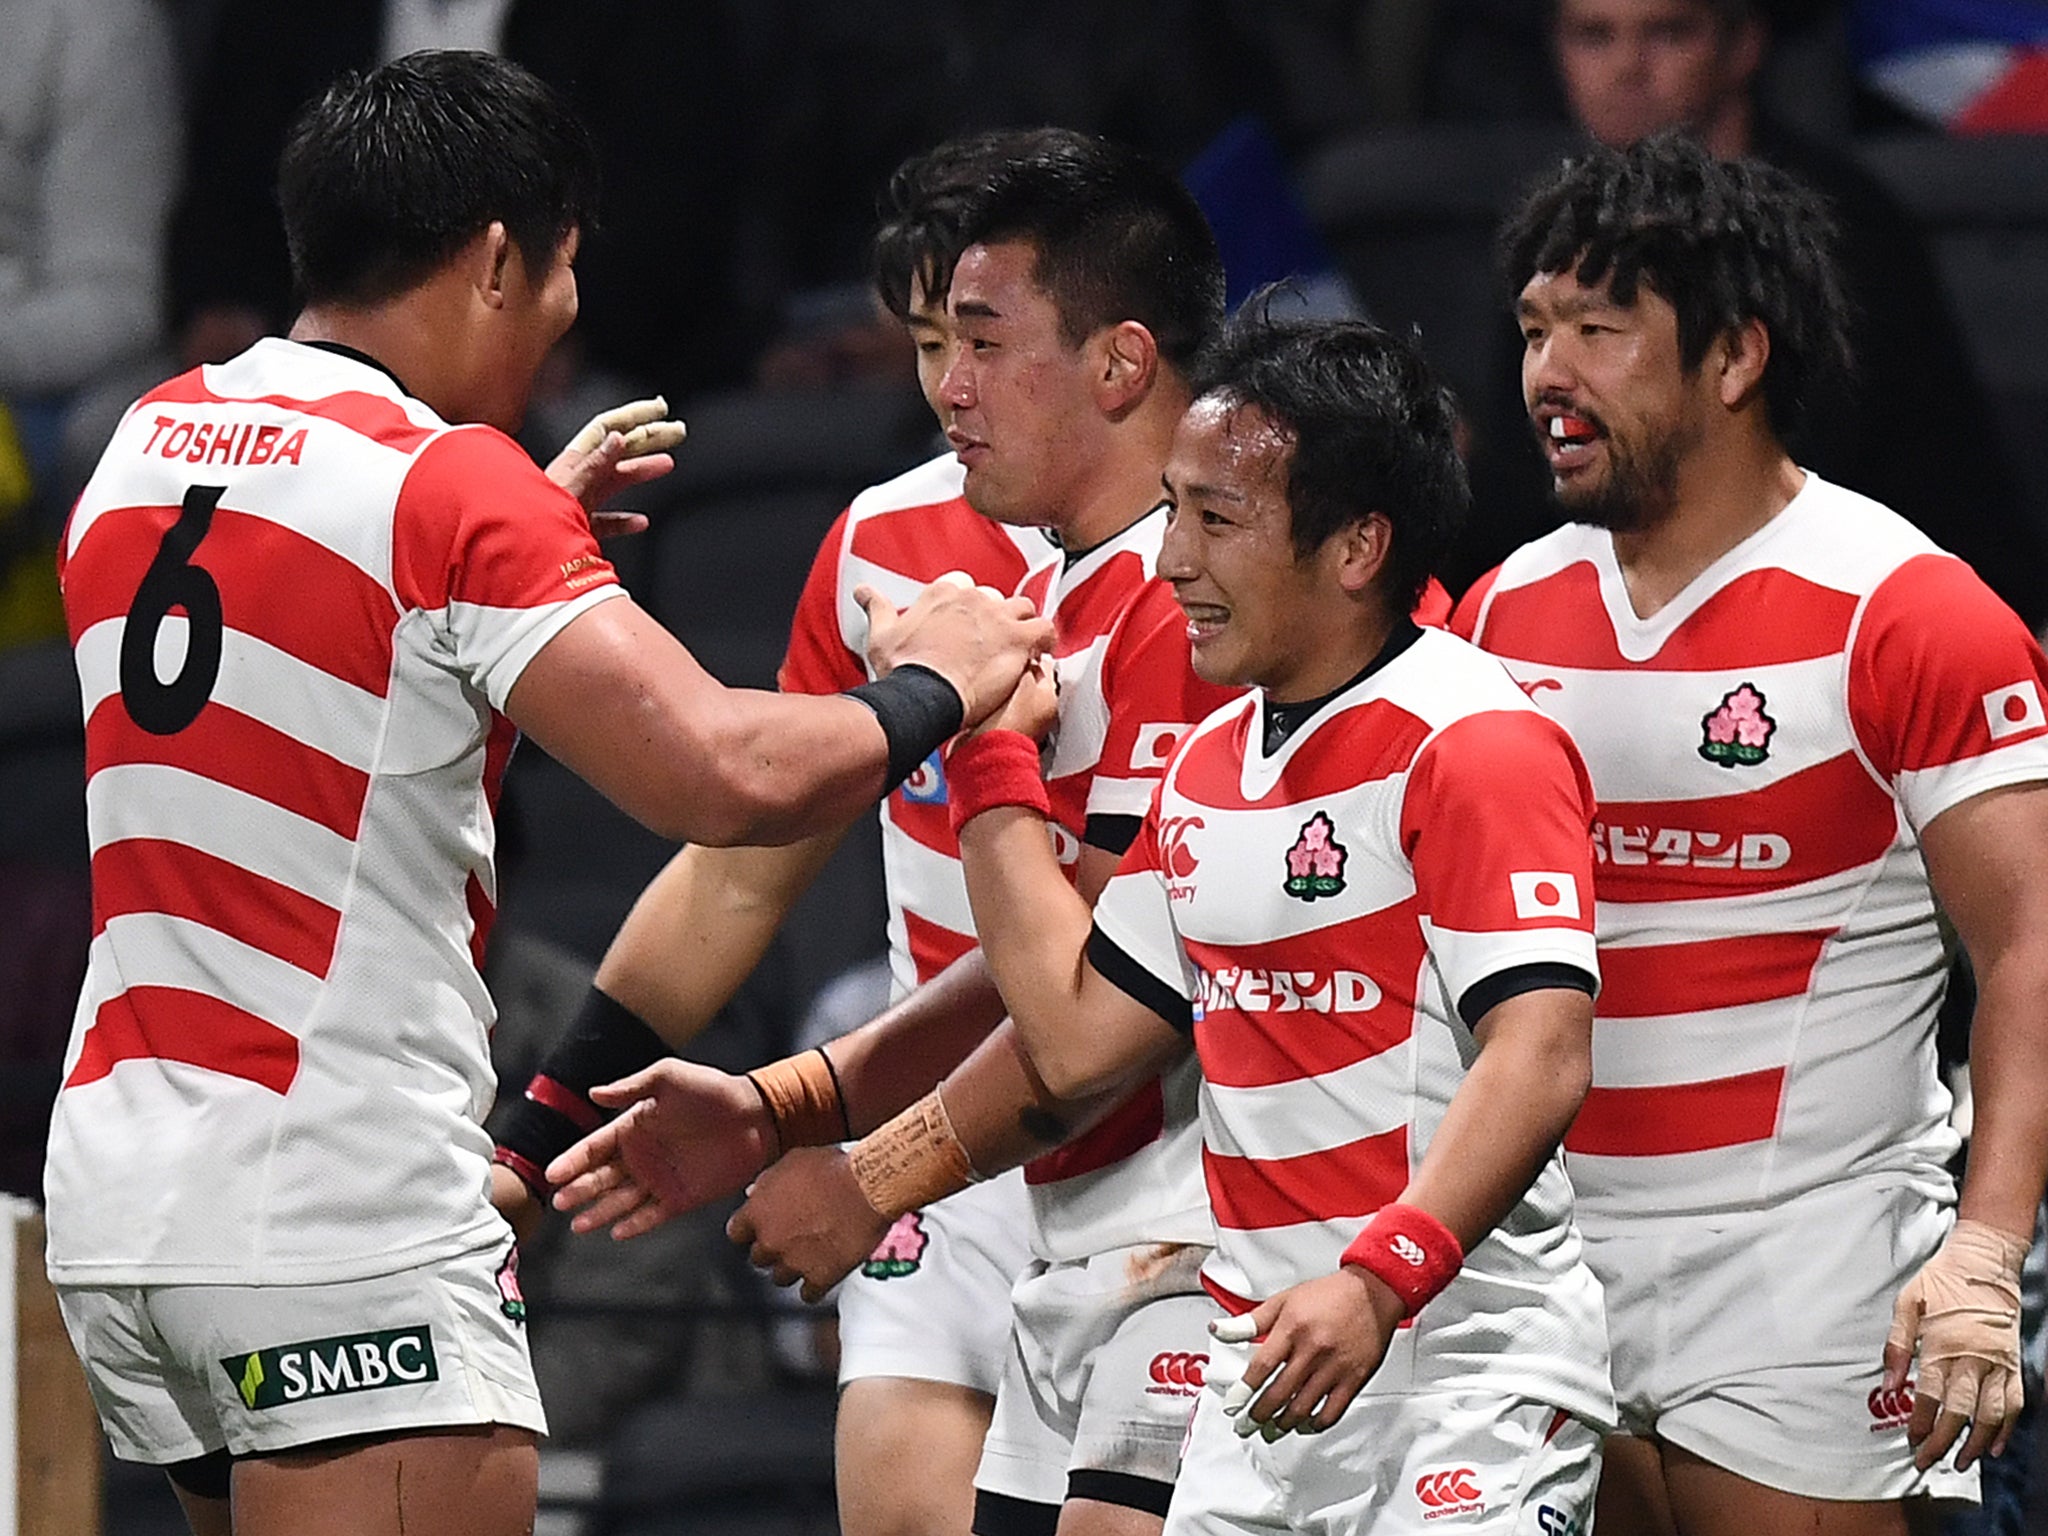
[1163,1343,1599,1536]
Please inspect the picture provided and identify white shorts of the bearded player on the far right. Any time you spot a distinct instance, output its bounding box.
[1579,1180,1978,1503]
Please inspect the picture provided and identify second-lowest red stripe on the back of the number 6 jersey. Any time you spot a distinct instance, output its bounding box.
[92,838,342,977]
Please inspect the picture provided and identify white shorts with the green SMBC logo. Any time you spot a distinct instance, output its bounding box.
[57,1237,547,1466]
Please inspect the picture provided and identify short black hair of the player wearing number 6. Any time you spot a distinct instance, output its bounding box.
[276,49,598,303]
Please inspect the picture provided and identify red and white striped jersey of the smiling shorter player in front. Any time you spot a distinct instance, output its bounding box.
[1090,629,1614,1423]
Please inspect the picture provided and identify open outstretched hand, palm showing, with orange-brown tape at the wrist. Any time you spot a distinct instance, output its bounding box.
[547,1057,776,1239]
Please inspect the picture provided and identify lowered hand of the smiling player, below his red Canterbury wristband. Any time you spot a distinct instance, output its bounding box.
[1208,1264,1403,1442]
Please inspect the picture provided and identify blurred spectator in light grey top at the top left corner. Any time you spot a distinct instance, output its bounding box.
[0,0,178,552]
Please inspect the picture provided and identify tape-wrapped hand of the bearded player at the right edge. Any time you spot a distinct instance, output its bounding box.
[1884,1221,2030,1470]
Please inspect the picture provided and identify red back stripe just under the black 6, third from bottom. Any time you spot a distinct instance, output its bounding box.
[86,694,371,838]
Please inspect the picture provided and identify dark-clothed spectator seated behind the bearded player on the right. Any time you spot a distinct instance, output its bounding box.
[1456,0,2048,627]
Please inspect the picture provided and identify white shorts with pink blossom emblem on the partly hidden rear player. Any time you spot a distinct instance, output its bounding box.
[838,1171,1030,1397]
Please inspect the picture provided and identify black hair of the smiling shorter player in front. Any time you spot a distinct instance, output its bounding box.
[1192,289,1470,612]
